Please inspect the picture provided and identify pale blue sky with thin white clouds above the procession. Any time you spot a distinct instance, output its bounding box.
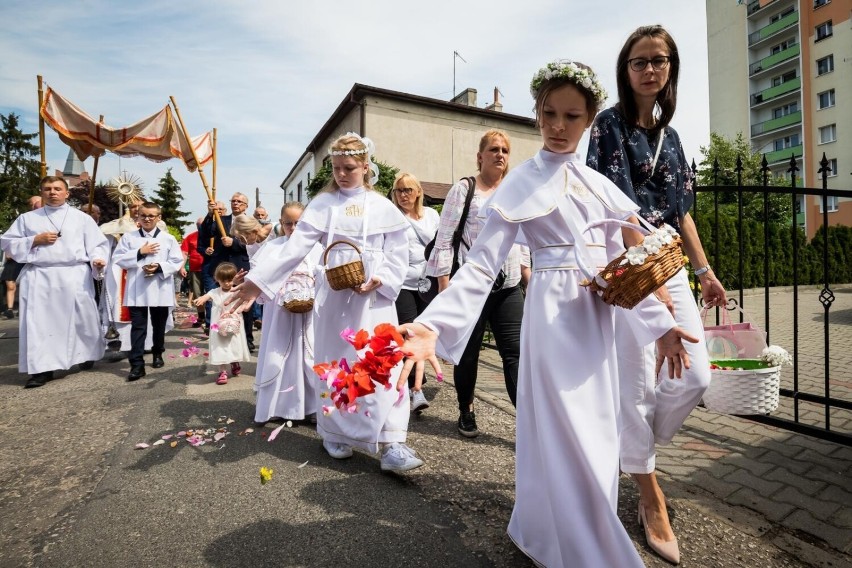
[0,0,712,229]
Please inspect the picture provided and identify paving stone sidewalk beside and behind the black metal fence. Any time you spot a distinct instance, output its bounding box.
[477,288,852,564]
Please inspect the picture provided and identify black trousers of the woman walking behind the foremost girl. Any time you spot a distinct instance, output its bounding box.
[453,286,524,410]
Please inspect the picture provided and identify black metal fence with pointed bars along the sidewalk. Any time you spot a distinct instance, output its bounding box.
[692,156,852,445]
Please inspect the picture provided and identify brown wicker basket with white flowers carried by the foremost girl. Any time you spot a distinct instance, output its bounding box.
[587,225,683,310]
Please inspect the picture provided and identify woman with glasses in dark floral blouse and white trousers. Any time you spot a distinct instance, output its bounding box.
[587,26,726,563]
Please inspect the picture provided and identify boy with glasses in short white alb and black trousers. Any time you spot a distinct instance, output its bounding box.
[113,201,183,381]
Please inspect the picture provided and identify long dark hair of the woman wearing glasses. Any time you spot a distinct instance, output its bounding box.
[615,25,680,136]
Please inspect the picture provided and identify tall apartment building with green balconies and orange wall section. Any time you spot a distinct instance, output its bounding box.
[706,0,852,236]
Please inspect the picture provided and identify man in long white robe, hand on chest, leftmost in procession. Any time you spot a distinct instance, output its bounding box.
[0,176,109,388]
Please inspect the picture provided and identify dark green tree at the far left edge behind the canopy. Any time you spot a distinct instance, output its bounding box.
[0,112,41,231]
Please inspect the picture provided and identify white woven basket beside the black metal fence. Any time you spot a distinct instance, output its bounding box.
[704,360,781,414]
